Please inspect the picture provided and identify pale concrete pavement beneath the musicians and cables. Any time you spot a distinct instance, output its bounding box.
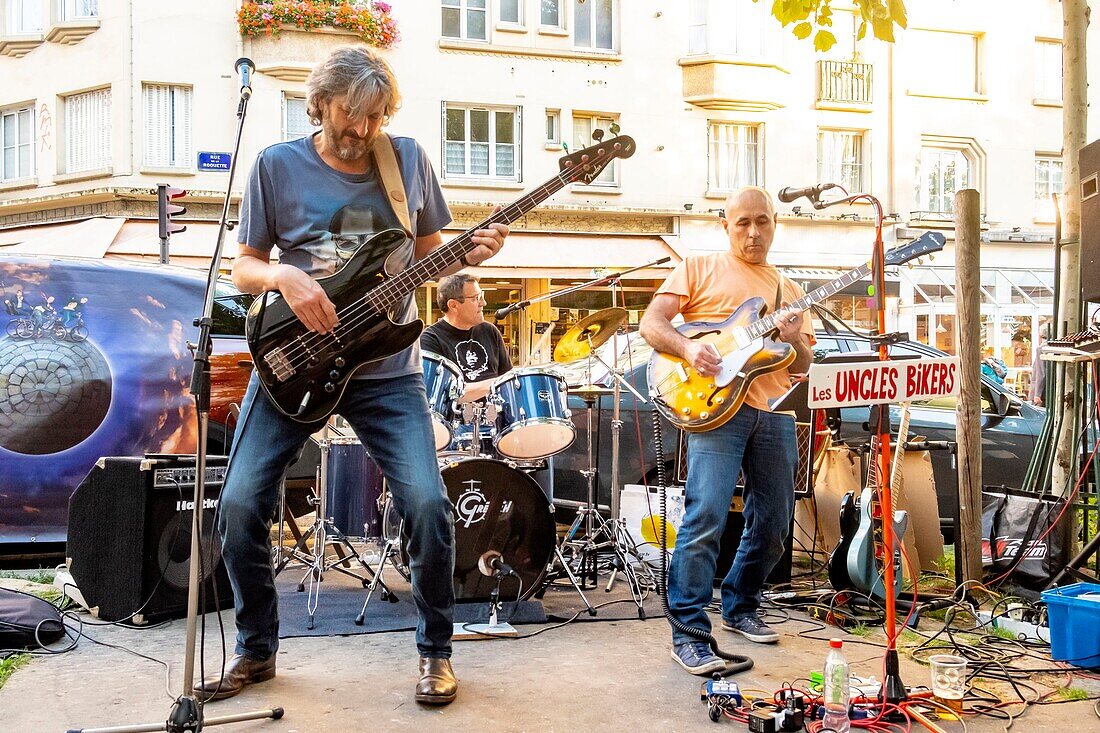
[0,576,1100,733]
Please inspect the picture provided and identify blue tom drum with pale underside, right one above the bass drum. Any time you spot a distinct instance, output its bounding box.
[491,369,576,460]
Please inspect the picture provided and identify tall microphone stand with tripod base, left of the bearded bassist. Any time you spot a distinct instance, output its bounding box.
[68,58,283,733]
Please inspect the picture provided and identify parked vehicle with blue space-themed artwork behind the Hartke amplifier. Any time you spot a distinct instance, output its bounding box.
[0,255,252,554]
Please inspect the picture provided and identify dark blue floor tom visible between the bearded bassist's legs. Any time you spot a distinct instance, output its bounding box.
[321,438,382,539]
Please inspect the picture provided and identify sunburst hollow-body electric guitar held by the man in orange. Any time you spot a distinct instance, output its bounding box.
[648,231,944,433]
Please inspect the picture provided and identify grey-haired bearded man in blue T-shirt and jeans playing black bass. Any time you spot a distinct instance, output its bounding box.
[196,46,508,704]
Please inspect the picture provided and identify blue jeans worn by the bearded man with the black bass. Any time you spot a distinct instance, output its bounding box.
[218,374,454,660]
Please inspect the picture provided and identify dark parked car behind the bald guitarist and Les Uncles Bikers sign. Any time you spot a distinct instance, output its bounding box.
[540,329,1045,536]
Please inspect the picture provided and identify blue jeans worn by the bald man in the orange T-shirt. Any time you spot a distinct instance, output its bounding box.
[669,405,798,644]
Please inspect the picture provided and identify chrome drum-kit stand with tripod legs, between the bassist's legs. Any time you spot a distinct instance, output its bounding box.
[279,439,389,630]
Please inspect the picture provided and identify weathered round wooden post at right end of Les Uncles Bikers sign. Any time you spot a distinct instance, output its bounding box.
[955,188,981,581]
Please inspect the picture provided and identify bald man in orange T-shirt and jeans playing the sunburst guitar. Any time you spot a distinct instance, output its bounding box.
[641,187,813,676]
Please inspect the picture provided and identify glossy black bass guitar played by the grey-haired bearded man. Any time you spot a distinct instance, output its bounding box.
[245,135,635,423]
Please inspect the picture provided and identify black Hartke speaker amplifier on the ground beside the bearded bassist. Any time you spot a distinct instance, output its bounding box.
[65,456,233,624]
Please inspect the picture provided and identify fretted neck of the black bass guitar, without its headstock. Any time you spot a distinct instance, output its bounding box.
[364,172,569,310]
